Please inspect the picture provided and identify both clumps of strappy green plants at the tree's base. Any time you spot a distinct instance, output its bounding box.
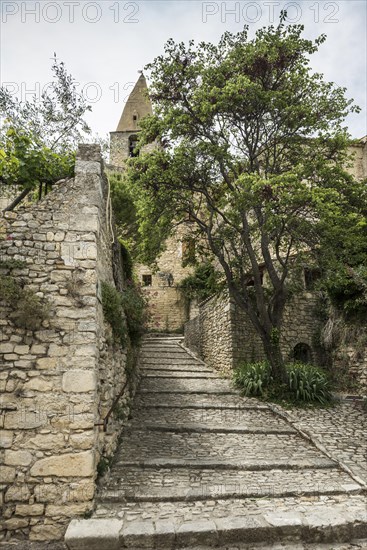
[234,362,331,405]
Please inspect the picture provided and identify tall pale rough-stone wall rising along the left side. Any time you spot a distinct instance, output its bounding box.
[0,146,138,540]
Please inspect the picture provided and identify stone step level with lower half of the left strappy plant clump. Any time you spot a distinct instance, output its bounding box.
[139,378,237,395]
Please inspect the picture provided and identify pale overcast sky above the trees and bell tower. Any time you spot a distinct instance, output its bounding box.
[0,0,367,138]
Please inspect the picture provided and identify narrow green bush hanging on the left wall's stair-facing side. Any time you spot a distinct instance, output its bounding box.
[102,281,126,347]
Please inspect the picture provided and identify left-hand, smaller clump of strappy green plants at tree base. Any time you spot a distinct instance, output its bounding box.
[234,361,272,396]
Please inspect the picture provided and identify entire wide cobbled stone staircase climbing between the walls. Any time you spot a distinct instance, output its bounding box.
[65,337,367,550]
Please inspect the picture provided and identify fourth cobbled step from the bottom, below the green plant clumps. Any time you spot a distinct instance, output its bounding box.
[131,406,294,432]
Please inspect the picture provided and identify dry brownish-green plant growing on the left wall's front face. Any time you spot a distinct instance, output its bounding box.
[0,275,50,331]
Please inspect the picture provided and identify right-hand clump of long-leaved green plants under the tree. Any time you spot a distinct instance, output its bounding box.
[286,363,331,404]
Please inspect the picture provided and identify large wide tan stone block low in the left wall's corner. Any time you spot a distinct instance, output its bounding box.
[30,451,95,477]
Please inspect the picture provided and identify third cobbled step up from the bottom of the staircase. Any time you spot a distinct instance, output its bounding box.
[115,427,334,464]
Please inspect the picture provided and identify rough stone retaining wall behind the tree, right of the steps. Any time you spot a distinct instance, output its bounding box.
[185,292,367,393]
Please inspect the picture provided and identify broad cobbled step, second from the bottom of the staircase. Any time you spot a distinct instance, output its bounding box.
[98,467,361,502]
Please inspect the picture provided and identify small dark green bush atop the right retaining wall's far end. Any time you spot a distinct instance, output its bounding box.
[178,262,223,302]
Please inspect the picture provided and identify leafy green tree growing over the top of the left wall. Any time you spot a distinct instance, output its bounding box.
[0,55,91,206]
